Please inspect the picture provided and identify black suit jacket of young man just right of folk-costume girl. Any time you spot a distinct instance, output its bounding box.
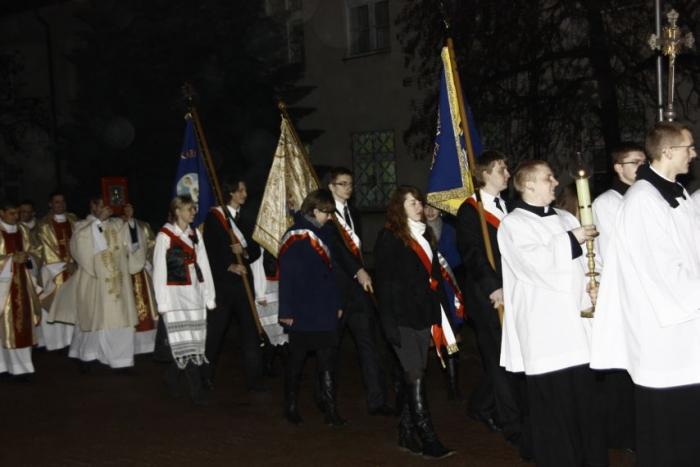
[204,208,260,297]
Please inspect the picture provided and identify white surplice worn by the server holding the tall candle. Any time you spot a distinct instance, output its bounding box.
[498,206,591,375]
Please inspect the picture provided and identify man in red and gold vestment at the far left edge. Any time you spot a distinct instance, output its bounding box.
[0,201,41,375]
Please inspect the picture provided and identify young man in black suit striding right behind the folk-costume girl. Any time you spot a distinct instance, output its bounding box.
[204,177,267,391]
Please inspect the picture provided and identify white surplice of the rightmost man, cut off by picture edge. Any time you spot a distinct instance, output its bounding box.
[591,180,700,388]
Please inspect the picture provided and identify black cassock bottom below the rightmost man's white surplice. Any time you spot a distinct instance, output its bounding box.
[635,384,700,467]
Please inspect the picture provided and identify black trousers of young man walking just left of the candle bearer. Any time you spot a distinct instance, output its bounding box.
[469,297,521,436]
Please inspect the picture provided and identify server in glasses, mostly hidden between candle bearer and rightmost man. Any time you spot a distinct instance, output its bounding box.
[593,142,647,449]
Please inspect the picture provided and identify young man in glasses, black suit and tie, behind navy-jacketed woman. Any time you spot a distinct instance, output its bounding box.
[324,167,393,416]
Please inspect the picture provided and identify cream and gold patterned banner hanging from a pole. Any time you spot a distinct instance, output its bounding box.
[253,115,318,258]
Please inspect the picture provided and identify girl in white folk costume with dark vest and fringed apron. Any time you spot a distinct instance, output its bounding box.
[153,196,216,405]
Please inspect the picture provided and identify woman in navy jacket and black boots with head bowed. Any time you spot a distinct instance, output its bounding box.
[279,190,346,426]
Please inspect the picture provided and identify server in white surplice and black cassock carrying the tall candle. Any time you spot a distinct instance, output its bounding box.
[498,161,607,467]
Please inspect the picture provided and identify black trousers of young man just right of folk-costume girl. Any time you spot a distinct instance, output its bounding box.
[205,282,263,388]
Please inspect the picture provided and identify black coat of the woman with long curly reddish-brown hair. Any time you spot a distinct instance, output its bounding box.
[374,228,447,344]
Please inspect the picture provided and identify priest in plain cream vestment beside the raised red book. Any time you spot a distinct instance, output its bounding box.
[49,198,138,369]
